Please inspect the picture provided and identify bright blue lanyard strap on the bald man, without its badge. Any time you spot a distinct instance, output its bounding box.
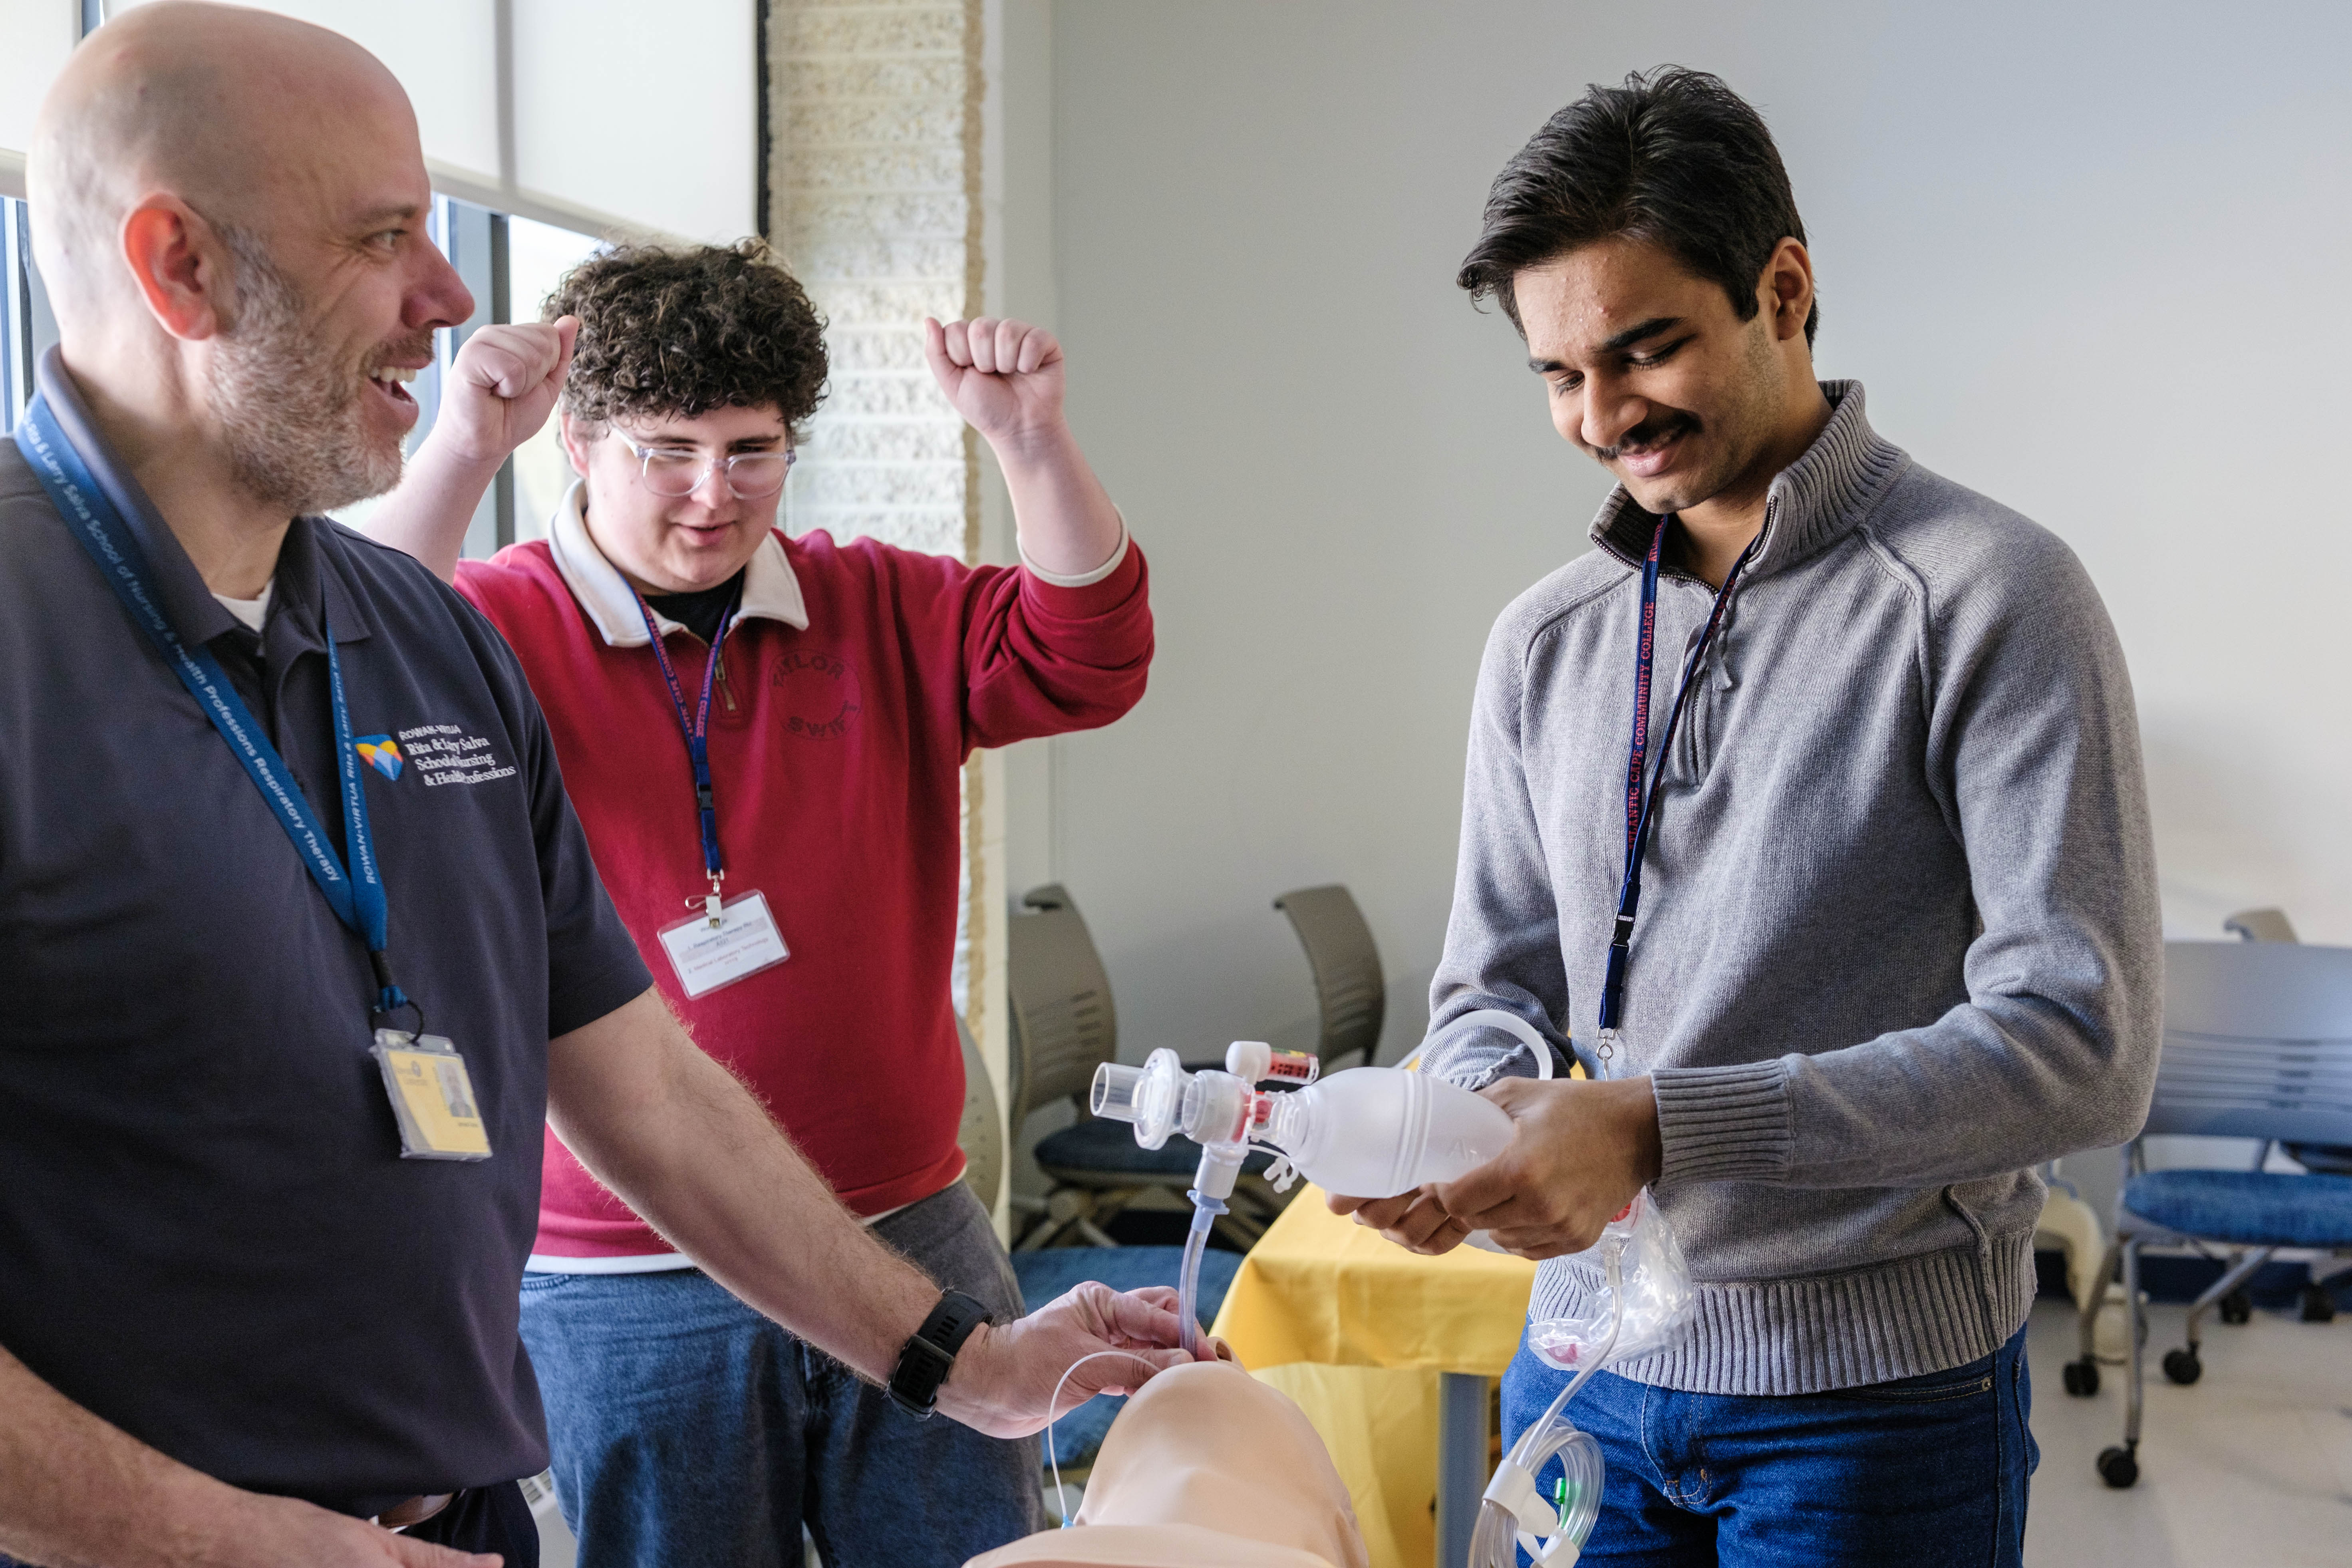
[16,395,416,1013]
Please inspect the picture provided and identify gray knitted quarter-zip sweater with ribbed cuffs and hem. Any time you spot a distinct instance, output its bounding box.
[1428,381,2161,1394]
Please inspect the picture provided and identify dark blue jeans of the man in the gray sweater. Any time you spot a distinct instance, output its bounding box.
[1503,1328,2042,1568]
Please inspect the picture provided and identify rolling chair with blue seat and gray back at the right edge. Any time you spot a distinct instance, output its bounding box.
[2065,943,2352,1486]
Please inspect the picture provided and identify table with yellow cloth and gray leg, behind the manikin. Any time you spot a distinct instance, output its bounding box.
[1214,1187,1536,1568]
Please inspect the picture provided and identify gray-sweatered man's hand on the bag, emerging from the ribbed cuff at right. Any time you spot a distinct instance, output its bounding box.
[1437,1079,1658,1258]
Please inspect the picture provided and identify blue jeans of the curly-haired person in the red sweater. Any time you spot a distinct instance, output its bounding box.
[522,1182,1044,1568]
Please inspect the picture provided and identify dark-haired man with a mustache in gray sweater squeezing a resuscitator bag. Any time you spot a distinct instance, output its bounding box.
[1333,71,2161,1568]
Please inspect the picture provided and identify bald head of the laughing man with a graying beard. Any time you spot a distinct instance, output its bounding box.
[26,0,473,515]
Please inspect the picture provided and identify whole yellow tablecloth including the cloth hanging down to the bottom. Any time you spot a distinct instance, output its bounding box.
[1216,1187,1536,1568]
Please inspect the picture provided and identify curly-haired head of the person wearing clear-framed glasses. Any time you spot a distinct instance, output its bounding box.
[543,240,826,592]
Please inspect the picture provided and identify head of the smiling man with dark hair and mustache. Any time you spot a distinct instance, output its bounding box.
[1458,68,1820,515]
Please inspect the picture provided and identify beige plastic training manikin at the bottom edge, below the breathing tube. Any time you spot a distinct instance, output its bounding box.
[964,1361,1369,1568]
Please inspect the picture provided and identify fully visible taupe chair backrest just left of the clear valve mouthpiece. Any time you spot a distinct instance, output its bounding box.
[1004,884,1120,1129]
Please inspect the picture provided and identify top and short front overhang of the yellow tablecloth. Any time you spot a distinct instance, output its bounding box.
[1216,1187,1536,1377]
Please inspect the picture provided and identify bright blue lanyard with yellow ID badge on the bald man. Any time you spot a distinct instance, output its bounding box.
[16,397,489,1159]
